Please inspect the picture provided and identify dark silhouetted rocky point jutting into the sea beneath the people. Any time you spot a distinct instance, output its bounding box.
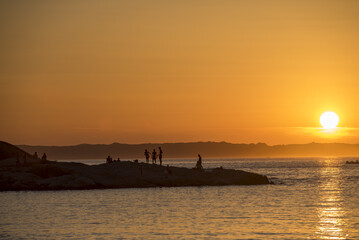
[0,159,270,191]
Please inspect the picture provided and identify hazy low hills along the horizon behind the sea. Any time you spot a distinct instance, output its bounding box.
[18,142,359,159]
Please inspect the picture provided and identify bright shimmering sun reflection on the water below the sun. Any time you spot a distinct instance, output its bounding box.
[316,159,348,239]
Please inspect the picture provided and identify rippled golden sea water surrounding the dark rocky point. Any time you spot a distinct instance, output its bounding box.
[0,158,359,239]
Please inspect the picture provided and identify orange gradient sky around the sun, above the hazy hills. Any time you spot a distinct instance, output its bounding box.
[0,0,359,145]
